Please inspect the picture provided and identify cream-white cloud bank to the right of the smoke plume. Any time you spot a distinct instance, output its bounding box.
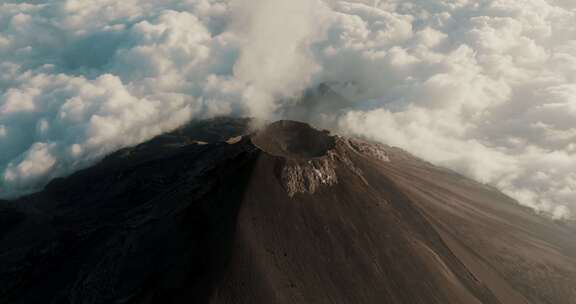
[320,0,576,218]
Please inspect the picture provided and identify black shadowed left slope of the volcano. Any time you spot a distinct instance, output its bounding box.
[0,120,258,304]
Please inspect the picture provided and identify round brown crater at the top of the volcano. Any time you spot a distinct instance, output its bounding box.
[252,120,336,159]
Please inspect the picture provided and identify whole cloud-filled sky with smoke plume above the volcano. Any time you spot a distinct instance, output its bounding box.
[0,0,576,219]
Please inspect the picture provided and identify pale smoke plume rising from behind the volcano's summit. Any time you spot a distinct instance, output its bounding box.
[233,0,327,117]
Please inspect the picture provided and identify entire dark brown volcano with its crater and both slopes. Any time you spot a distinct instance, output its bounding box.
[0,119,576,304]
